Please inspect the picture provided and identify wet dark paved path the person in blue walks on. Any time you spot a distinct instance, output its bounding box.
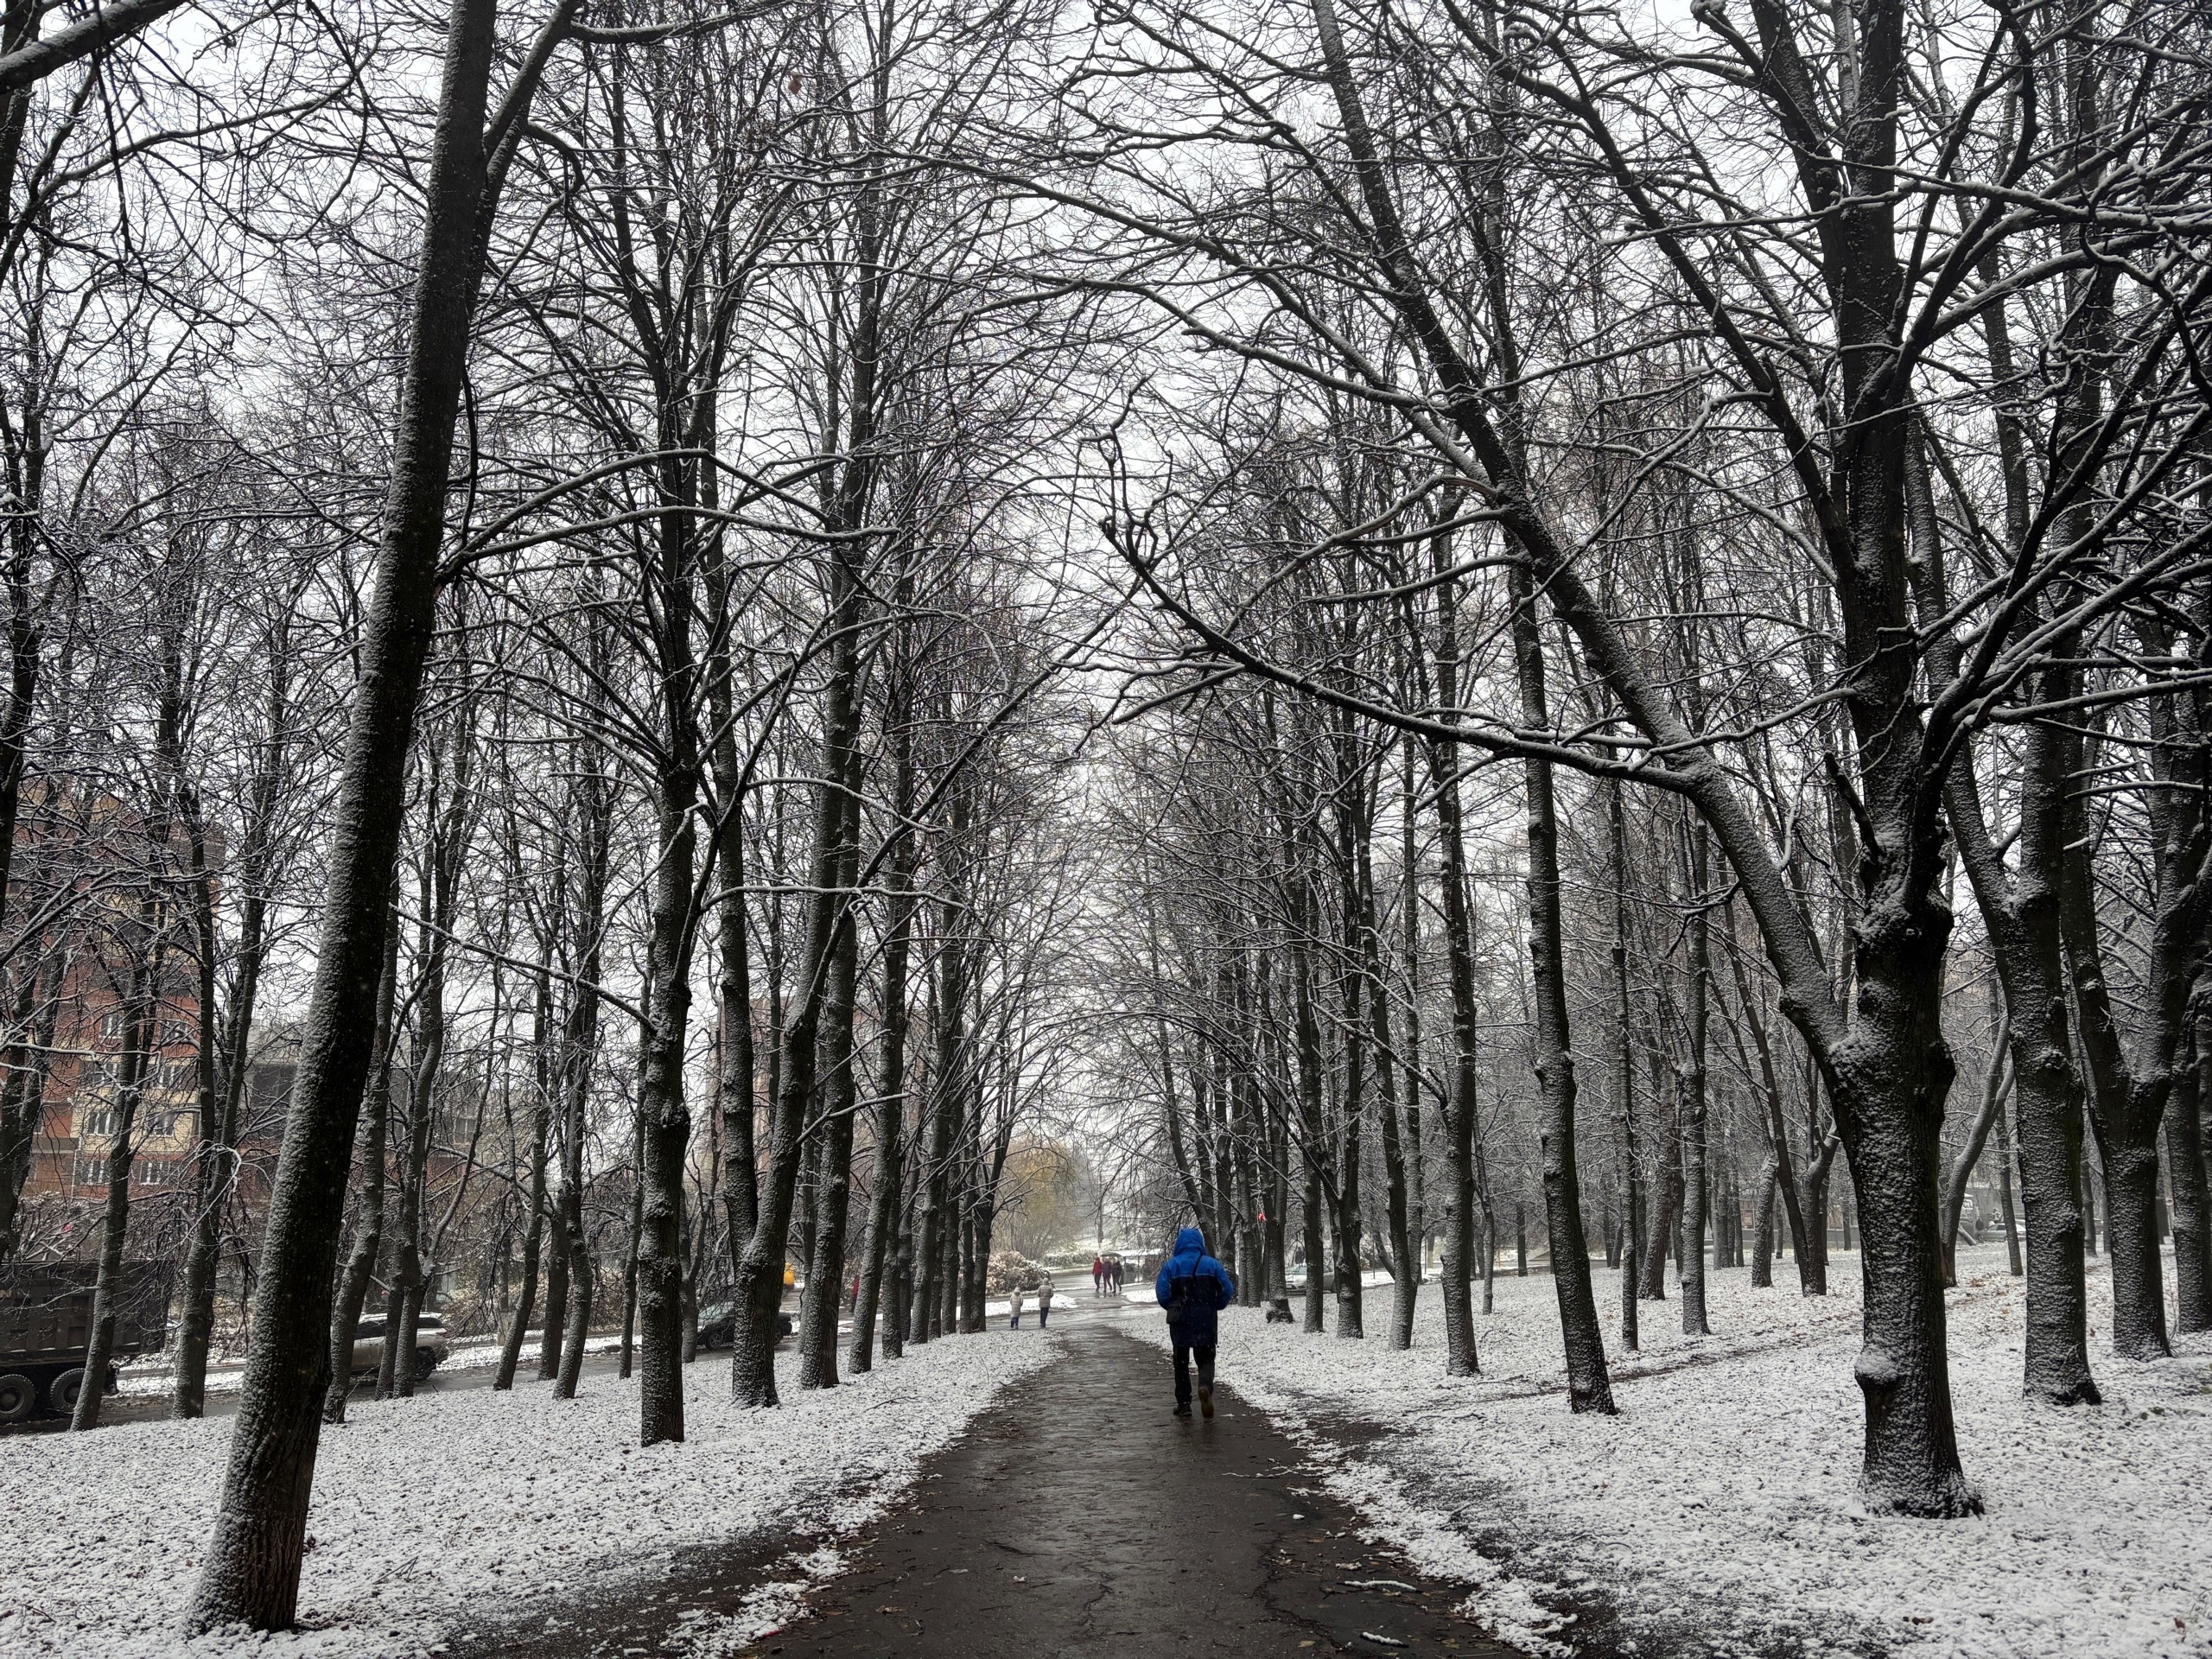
[754,1327,1513,1659]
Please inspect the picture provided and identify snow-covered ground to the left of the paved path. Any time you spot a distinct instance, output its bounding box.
[0,1332,1055,1659]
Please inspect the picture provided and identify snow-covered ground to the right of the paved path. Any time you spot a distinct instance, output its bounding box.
[1130,1245,2212,1659]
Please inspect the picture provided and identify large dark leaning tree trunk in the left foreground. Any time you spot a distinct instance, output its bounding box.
[186,0,557,1632]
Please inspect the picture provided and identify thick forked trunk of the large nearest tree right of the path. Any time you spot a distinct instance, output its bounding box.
[1312,0,1978,1516]
